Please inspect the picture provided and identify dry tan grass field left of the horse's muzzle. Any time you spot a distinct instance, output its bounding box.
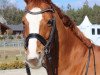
[0,47,25,62]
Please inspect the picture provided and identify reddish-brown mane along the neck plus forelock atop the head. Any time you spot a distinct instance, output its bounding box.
[24,0,92,47]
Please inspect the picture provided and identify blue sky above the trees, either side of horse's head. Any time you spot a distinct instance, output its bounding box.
[10,0,100,9]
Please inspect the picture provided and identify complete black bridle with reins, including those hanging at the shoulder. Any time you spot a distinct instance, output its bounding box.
[25,8,96,75]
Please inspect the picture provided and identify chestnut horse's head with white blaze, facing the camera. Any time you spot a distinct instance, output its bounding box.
[22,0,55,68]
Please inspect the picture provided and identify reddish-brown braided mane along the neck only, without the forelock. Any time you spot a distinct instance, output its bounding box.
[51,2,92,47]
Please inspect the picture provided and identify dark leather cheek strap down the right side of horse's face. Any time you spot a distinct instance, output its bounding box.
[44,18,56,75]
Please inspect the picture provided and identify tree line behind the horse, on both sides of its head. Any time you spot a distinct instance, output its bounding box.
[0,0,100,25]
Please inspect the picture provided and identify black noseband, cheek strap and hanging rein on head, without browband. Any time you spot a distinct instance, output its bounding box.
[25,18,56,75]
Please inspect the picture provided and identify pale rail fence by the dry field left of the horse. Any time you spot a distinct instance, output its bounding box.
[0,39,24,61]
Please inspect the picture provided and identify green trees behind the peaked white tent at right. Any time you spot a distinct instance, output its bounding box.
[65,1,100,25]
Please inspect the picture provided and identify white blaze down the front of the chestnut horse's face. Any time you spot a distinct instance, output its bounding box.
[26,8,42,59]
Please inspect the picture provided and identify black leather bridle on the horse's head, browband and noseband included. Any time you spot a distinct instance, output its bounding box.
[25,8,56,75]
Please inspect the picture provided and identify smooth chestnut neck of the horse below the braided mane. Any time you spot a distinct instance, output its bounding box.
[56,14,87,74]
